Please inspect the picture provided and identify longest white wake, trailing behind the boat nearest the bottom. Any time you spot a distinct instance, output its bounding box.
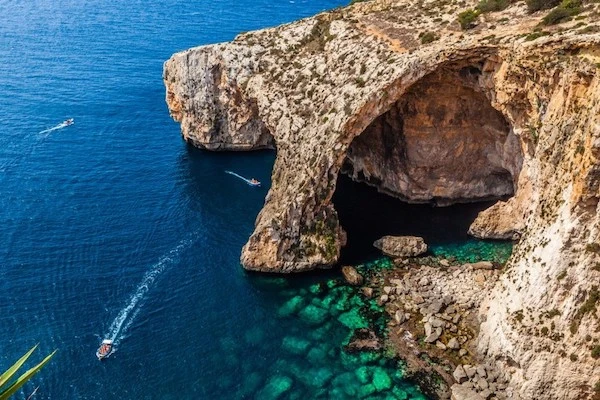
[104,239,193,345]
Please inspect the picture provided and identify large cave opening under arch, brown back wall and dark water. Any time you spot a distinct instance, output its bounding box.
[333,64,523,263]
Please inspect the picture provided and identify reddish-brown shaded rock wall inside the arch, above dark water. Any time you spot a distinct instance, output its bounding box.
[344,66,522,204]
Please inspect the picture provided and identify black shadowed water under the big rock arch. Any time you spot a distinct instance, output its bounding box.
[333,175,502,264]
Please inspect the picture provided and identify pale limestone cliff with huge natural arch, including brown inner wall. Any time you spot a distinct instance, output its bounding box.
[164,0,600,399]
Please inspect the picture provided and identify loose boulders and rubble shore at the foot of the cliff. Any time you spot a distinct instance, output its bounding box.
[343,250,518,400]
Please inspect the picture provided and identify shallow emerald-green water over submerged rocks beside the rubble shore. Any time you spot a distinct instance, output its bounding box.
[219,236,511,399]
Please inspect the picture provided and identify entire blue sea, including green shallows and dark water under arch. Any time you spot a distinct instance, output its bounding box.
[0,0,510,400]
